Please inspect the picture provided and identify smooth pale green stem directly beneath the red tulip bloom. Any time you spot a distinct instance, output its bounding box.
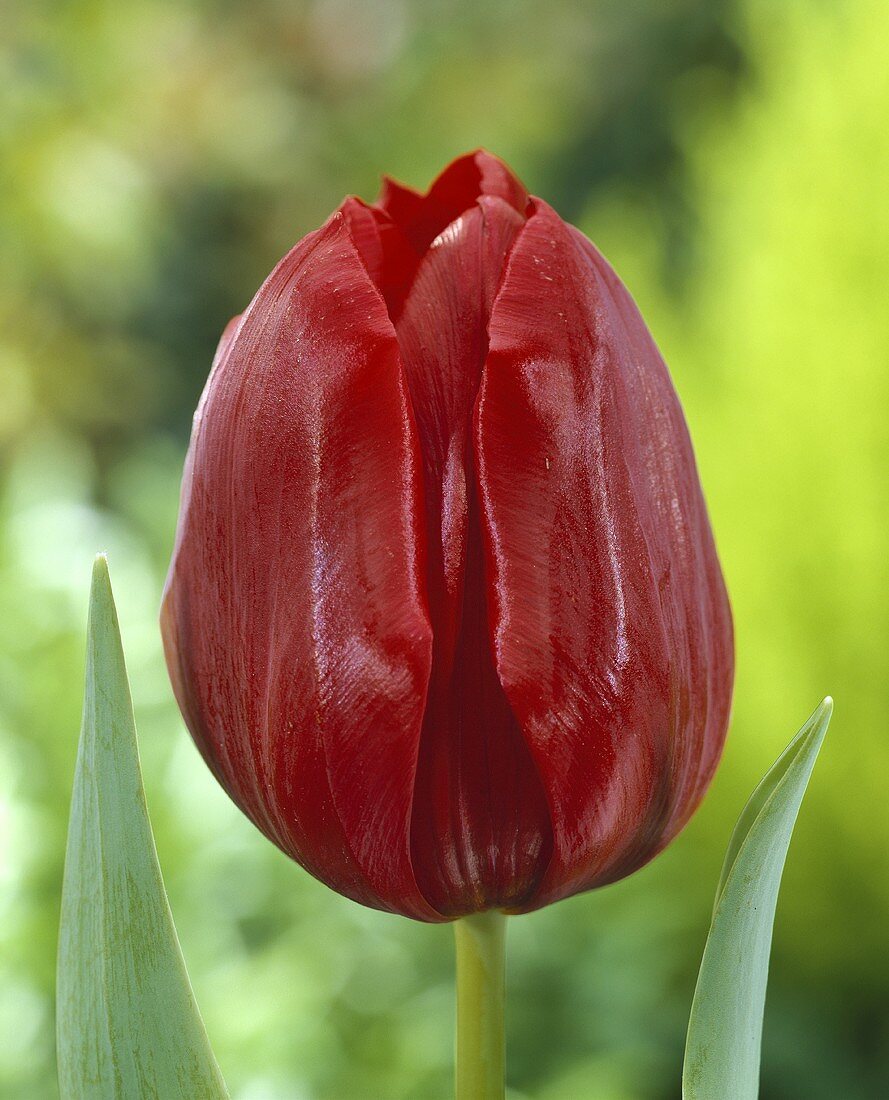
[453,910,506,1100]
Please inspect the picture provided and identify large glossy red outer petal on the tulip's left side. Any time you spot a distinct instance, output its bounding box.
[163,213,439,920]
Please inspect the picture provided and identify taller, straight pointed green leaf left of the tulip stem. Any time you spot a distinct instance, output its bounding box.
[56,557,228,1100]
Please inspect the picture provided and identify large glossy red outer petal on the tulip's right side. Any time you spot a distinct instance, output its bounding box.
[475,200,733,908]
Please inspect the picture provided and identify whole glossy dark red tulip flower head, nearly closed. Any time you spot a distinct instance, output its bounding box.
[162,153,733,921]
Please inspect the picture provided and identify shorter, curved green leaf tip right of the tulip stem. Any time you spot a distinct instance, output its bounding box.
[682,697,833,1100]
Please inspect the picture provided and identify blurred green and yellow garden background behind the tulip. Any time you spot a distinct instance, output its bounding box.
[0,0,889,1100]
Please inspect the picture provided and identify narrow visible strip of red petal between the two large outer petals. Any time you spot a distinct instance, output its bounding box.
[397,198,550,915]
